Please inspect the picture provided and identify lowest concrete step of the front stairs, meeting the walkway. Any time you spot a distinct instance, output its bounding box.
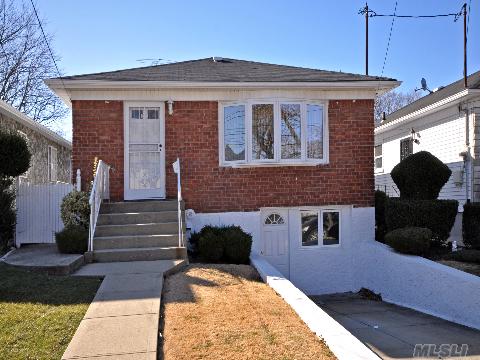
[93,247,187,262]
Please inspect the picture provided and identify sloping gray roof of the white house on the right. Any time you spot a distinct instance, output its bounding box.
[377,71,480,127]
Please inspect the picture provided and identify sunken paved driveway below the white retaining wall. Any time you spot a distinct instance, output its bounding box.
[311,293,480,360]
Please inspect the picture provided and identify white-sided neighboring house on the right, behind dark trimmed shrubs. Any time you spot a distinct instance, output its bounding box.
[374,72,480,212]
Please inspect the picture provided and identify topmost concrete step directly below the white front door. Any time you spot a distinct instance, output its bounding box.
[100,200,182,214]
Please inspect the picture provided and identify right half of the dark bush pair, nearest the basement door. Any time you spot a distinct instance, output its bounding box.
[224,226,252,264]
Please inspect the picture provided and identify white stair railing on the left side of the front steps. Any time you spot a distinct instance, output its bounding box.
[88,160,110,251]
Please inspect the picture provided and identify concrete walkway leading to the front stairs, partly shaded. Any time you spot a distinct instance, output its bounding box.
[62,260,183,360]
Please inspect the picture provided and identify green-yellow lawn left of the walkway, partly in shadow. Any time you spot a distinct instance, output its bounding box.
[0,263,101,360]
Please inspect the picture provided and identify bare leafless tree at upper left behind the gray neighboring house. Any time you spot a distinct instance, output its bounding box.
[0,0,67,124]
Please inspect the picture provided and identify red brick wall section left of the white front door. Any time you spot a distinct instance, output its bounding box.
[72,100,123,200]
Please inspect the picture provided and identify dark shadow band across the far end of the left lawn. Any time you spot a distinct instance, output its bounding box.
[0,263,102,305]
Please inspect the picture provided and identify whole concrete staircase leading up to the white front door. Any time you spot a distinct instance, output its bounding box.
[93,200,187,262]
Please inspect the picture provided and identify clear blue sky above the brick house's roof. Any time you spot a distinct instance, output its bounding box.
[36,0,480,137]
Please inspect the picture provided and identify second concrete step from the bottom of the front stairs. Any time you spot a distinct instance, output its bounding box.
[93,234,178,250]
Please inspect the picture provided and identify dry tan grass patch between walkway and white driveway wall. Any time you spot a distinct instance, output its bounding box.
[159,264,335,360]
